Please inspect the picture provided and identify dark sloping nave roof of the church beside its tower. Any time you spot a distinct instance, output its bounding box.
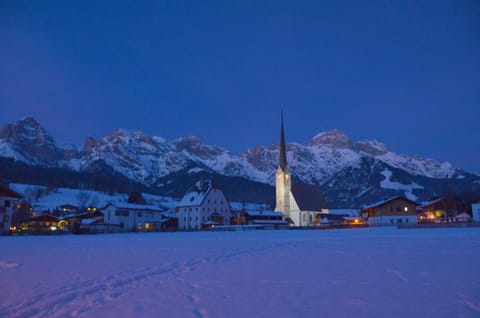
[291,182,327,211]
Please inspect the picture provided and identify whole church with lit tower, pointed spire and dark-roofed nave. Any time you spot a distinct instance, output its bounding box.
[275,112,328,226]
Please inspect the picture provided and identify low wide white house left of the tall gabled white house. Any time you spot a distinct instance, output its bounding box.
[103,203,167,232]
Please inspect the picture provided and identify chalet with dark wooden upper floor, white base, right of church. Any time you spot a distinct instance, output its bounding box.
[362,196,418,225]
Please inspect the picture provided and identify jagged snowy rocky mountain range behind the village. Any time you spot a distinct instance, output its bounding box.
[0,117,480,207]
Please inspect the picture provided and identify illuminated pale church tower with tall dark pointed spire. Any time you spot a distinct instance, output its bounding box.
[275,111,292,219]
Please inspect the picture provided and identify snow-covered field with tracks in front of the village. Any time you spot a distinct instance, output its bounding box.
[0,228,480,317]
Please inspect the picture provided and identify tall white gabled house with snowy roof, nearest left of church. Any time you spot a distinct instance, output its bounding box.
[176,180,231,230]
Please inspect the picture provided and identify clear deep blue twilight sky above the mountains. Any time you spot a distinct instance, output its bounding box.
[0,0,480,173]
